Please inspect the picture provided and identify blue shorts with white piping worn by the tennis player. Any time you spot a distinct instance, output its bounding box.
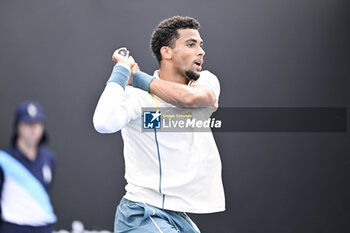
[114,198,200,233]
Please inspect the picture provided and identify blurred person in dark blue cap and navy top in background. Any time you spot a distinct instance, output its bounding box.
[0,101,56,233]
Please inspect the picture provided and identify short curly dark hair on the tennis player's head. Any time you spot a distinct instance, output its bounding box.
[151,16,200,64]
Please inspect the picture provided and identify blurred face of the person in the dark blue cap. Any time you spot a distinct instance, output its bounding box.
[18,122,44,146]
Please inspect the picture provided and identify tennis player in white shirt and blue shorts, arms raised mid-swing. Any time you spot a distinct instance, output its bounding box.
[93,16,225,233]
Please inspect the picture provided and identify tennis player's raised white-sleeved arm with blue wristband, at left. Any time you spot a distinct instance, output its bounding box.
[93,50,135,133]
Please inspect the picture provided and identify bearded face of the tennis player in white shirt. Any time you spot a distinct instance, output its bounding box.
[172,29,205,80]
